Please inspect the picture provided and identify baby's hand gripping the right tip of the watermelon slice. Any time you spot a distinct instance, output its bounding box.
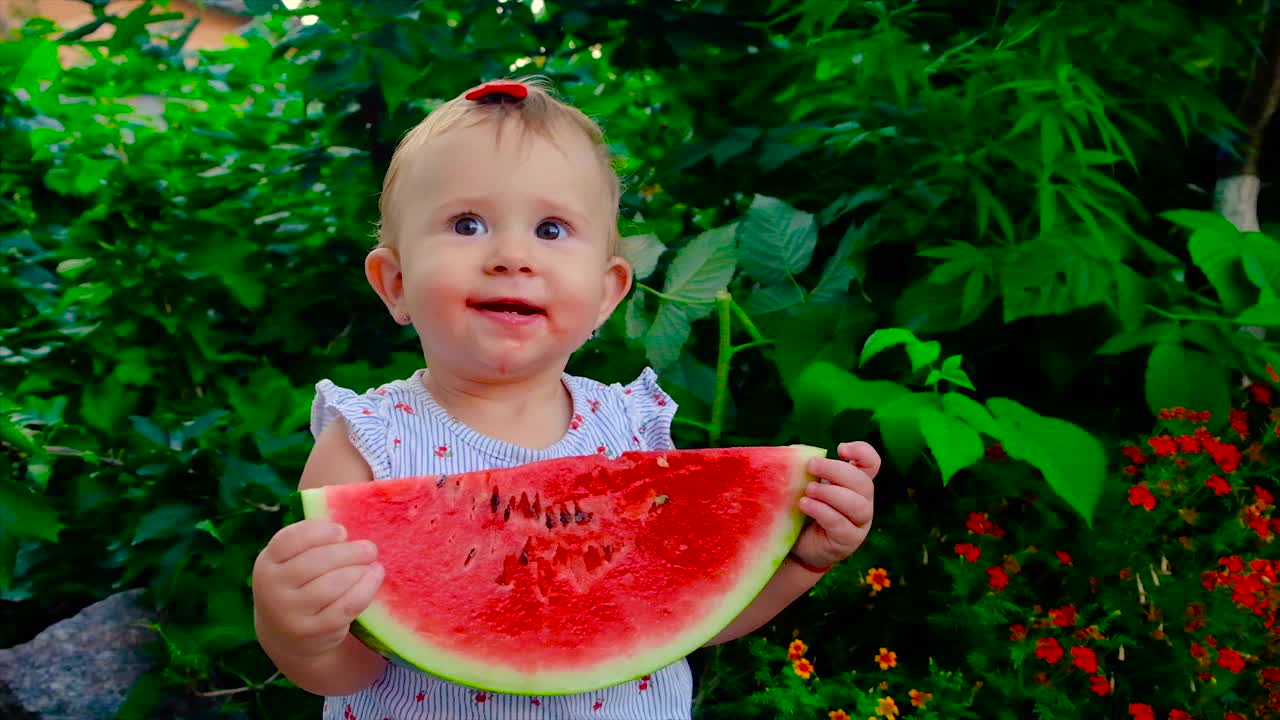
[791,442,881,568]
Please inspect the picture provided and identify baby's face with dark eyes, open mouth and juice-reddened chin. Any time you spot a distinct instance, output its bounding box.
[393,114,631,378]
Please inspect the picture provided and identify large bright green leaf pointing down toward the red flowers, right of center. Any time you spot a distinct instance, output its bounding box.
[987,397,1107,528]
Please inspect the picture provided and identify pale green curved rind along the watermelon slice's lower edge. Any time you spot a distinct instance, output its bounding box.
[301,445,827,696]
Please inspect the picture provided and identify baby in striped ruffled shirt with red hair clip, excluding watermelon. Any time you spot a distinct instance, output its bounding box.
[253,75,879,720]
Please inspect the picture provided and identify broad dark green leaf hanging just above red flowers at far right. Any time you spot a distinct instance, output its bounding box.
[1146,342,1231,423]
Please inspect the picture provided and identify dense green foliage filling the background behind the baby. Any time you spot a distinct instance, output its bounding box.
[0,0,1280,719]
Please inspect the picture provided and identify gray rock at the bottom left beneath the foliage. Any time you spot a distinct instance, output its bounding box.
[0,589,240,720]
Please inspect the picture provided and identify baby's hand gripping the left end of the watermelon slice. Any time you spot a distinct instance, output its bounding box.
[253,520,383,657]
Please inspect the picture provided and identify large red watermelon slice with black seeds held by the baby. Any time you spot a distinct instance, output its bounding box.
[301,446,826,696]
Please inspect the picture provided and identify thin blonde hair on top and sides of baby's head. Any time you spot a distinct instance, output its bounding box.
[376,76,622,255]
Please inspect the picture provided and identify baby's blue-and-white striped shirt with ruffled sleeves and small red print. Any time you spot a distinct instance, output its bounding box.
[311,368,692,720]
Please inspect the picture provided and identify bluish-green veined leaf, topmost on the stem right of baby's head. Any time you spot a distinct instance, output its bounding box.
[737,195,818,286]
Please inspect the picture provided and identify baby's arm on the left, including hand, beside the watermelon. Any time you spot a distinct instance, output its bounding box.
[253,419,387,696]
